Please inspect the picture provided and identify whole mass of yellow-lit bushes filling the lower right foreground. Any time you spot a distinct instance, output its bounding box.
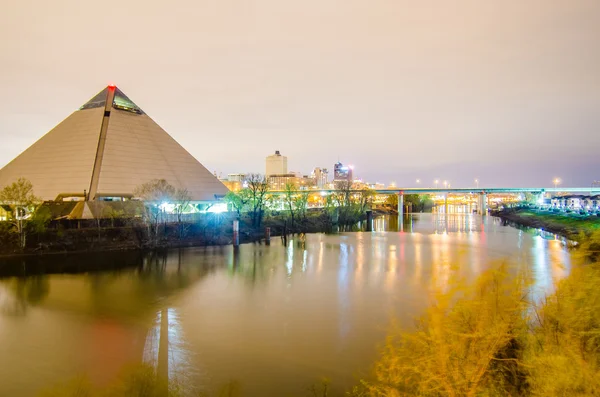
[354,230,600,397]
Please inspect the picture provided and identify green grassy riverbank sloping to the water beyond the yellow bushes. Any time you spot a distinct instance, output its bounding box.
[490,208,600,241]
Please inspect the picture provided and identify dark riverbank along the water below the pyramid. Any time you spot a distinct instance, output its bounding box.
[0,210,386,260]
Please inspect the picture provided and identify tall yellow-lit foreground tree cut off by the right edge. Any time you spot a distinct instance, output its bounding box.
[526,256,600,397]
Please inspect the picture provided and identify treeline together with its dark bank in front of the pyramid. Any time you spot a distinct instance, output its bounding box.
[0,175,360,254]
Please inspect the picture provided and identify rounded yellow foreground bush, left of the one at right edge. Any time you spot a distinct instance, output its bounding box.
[368,266,528,397]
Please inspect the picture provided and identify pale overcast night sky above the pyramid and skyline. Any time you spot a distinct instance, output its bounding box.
[0,0,600,187]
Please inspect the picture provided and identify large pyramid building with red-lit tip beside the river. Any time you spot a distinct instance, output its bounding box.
[0,85,228,202]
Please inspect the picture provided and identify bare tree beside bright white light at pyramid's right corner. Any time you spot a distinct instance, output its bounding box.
[134,179,177,245]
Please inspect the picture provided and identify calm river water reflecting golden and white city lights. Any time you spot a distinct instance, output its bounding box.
[0,214,570,396]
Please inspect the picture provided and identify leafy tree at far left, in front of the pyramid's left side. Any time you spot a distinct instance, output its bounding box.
[0,178,41,249]
